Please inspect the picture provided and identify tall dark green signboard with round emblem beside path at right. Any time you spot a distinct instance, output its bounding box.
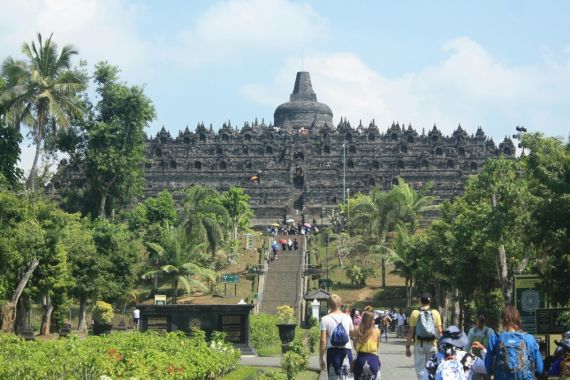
[515,275,546,334]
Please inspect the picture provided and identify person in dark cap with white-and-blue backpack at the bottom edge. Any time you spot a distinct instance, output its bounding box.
[423,326,487,380]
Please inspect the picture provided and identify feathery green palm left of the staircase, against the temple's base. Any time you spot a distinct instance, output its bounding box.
[182,186,231,259]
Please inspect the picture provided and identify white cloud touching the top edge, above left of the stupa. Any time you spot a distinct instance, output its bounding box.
[165,0,327,66]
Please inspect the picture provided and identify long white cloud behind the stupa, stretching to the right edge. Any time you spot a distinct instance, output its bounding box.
[241,37,570,142]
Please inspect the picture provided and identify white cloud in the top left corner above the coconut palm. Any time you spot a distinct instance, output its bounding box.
[0,0,148,77]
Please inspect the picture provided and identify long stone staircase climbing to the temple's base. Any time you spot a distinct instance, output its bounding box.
[260,235,304,316]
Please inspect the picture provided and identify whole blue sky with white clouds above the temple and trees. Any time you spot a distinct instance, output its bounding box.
[0,0,570,172]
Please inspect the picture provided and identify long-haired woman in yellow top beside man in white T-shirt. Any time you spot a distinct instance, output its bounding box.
[353,311,380,380]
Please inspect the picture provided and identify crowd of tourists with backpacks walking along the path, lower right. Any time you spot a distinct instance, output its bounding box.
[319,293,570,380]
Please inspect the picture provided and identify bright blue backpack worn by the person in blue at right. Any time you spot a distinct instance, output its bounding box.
[493,331,536,380]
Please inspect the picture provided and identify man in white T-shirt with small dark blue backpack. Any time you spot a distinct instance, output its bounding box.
[319,294,354,379]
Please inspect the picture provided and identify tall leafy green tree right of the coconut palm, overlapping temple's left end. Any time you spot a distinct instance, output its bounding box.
[85,62,155,218]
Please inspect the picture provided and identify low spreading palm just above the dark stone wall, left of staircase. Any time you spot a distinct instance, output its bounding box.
[142,222,216,304]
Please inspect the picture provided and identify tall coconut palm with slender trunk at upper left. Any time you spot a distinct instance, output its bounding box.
[0,33,87,192]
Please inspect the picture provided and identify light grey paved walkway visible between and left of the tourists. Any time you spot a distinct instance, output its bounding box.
[240,333,415,380]
